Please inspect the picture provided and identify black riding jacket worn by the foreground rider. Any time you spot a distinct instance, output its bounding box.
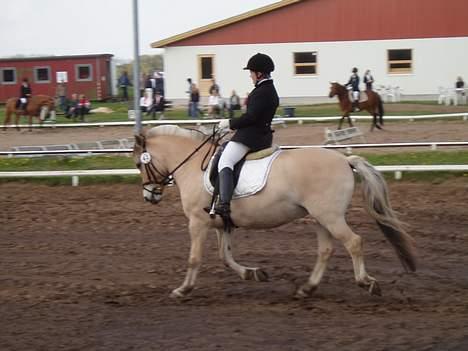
[229,79,279,151]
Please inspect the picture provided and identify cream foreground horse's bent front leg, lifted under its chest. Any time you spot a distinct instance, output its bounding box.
[216,230,268,282]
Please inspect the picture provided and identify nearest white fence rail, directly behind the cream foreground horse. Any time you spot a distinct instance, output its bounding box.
[0,165,468,186]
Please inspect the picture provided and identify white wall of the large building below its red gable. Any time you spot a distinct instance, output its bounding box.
[164,37,468,103]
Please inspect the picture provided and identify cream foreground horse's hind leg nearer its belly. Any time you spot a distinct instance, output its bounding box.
[296,225,333,298]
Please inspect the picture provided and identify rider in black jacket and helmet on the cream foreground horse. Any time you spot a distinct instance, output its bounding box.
[216,53,279,219]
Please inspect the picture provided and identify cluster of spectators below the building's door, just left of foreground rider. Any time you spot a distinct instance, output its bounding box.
[187,78,247,118]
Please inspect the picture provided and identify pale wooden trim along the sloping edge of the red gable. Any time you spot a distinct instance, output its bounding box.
[151,0,303,48]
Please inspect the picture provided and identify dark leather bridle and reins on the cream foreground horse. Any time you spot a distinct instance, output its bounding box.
[136,127,227,202]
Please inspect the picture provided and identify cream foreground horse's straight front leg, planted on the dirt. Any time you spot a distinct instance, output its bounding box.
[170,218,208,298]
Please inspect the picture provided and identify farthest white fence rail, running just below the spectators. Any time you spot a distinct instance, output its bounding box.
[6,112,468,128]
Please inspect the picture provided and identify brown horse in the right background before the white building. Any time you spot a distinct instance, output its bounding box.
[328,82,384,131]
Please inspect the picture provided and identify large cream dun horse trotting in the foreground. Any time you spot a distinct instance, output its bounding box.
[133,125,416,297]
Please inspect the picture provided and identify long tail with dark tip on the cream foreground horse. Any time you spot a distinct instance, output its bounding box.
[347,156,416,272]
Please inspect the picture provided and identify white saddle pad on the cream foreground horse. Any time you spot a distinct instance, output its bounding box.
[203,150,281,199]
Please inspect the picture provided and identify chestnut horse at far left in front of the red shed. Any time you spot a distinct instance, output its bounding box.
[3,95,55,131]
